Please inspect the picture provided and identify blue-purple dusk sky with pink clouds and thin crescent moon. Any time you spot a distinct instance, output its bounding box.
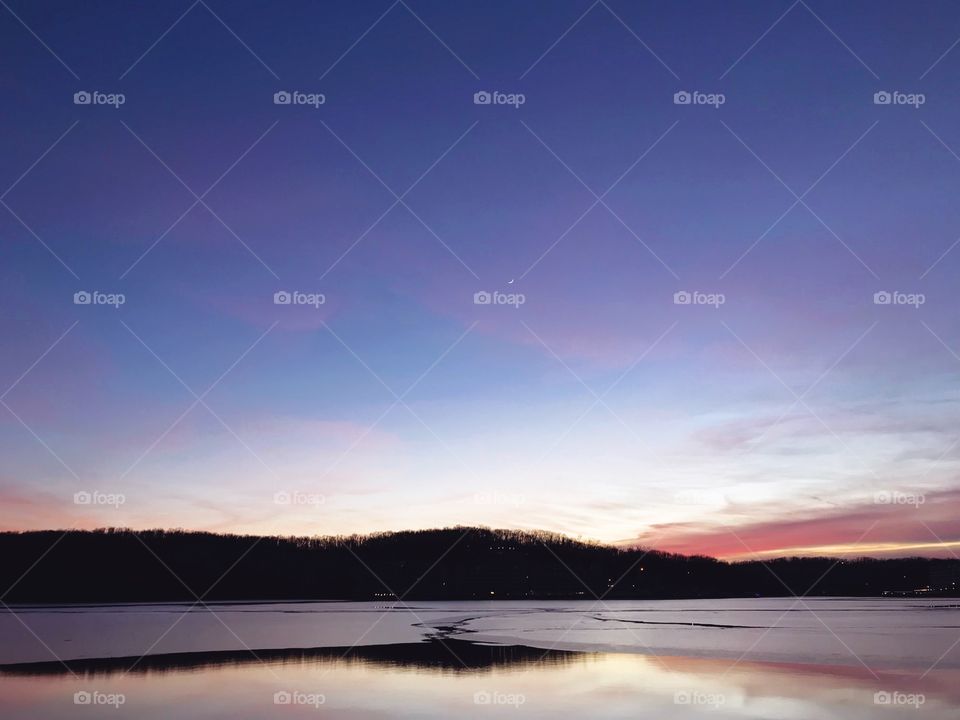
[0,0,960,558]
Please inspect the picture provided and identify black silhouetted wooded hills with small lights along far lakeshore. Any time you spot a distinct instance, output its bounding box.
[0,527,960,604]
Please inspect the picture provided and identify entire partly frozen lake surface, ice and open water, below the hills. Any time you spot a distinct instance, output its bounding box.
[0,598,960,719]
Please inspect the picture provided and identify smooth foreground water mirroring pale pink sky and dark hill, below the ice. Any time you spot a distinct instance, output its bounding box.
[0,640,960,720]
